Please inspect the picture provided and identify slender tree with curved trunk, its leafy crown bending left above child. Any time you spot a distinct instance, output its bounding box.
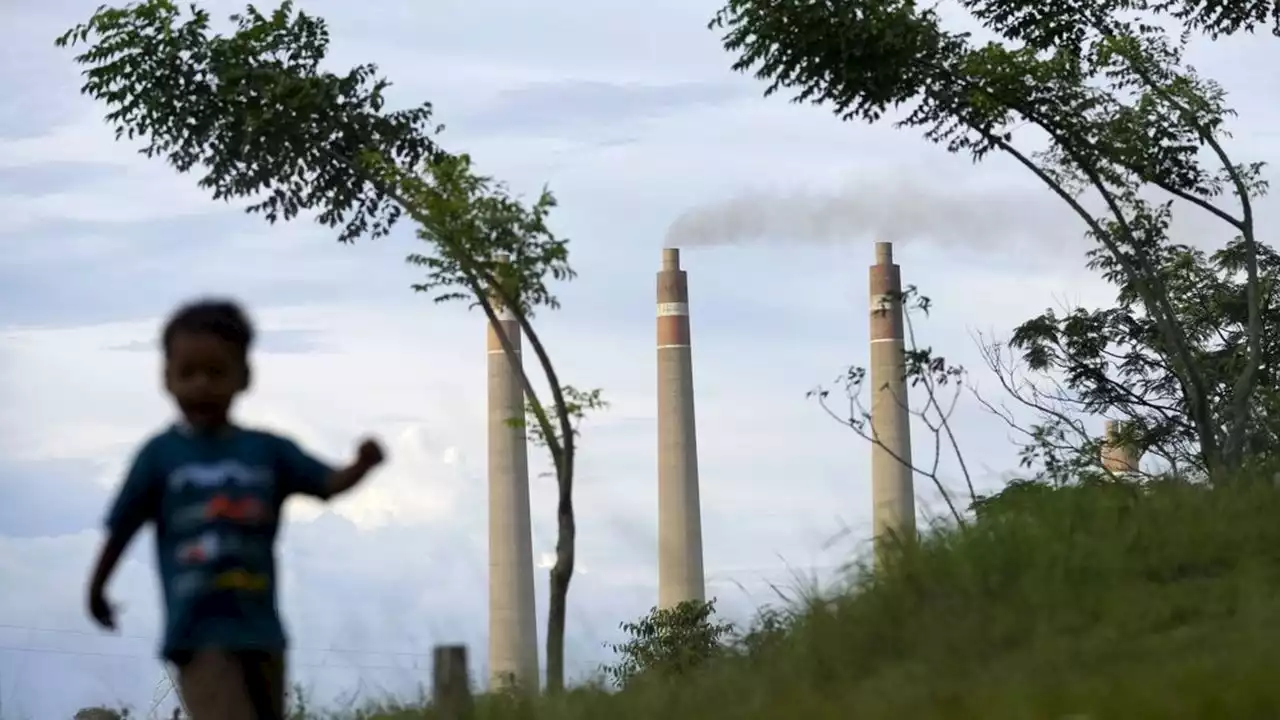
[58,0,596,692]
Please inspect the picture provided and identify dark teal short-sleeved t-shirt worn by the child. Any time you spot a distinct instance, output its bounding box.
[106,425,333,660]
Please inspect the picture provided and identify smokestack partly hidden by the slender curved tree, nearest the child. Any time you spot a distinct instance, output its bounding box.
[488,255,539,689]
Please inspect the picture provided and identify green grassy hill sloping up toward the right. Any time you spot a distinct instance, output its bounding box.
[355,474,1280,720]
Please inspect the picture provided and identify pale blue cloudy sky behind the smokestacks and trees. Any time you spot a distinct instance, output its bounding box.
[0,0,1280,720]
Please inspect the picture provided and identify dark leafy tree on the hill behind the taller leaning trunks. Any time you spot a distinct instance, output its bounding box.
[979,240,1280,483]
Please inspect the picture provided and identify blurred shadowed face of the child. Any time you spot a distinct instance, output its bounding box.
[165,332,248,428]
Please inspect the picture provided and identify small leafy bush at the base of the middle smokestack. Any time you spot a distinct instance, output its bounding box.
[604,598,737,688]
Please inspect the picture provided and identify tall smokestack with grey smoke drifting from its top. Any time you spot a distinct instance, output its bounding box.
[658,247,707,607]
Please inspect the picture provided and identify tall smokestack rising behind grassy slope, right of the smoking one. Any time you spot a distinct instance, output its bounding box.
[870,242,915,550]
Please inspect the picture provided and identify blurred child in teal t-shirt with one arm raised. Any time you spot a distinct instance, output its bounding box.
[88,294,383,720]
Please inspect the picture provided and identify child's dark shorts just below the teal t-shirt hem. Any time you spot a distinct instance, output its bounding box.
[173,650,284,720]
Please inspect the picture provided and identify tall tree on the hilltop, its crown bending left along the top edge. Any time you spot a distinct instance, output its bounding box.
[710,0,1280,477]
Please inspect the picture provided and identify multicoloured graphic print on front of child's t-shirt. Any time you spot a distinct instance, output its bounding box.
[169,460,275,597]
